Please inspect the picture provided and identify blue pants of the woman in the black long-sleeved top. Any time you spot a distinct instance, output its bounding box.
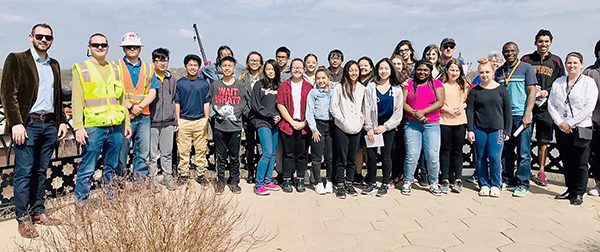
[473,126,504,189]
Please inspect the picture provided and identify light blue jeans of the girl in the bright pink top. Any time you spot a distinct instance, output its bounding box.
[404,119,440,184]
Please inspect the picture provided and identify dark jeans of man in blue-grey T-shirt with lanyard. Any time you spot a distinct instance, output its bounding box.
[502,116,532,190]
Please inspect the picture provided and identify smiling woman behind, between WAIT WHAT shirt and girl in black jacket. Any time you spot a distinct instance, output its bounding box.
[238,51,263,184]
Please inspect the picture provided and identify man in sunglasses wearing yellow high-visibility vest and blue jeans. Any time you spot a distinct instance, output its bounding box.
[71,33,131,207]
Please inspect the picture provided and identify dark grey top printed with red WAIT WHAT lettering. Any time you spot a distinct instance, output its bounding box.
[209,80,250,132]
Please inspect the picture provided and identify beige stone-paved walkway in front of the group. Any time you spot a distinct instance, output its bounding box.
[0,172,600,252]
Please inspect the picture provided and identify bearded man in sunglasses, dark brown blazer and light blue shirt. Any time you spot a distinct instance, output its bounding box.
[0,24,67,238]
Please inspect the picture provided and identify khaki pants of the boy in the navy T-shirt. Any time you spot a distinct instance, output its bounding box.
[177,118,208,176]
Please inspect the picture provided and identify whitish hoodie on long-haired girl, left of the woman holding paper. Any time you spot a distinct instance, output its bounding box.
[331,83,369,134]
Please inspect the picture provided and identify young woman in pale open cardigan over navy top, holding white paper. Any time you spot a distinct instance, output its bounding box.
[361,58,406,197]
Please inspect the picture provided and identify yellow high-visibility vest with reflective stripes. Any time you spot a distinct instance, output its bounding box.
[73,60,128,128]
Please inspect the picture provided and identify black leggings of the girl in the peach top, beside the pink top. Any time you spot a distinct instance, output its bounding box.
[440,124,466,181]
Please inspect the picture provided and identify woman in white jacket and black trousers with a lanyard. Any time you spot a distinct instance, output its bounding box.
[548,52,598,205]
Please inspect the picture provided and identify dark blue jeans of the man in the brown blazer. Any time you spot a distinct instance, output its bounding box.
[14,118,58,223]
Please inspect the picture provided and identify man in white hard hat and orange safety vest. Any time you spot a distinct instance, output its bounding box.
[114,32,160,179]
